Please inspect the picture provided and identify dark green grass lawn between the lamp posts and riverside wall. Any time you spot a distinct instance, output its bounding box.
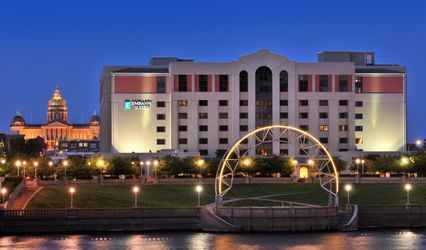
[27,184,426,209]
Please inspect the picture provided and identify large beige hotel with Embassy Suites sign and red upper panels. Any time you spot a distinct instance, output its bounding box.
[100,50,407,156]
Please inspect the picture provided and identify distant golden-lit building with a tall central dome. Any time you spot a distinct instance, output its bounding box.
[10,88,100,151]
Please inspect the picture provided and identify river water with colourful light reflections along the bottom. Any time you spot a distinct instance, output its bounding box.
[0,230,426,250]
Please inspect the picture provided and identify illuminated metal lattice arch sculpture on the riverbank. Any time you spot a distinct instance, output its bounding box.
[215,125,339,206]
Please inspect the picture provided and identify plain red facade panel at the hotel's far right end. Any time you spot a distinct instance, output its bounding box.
[362,76,404,93]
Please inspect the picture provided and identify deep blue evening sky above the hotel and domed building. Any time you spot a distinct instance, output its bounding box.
[0,0,426,142]
